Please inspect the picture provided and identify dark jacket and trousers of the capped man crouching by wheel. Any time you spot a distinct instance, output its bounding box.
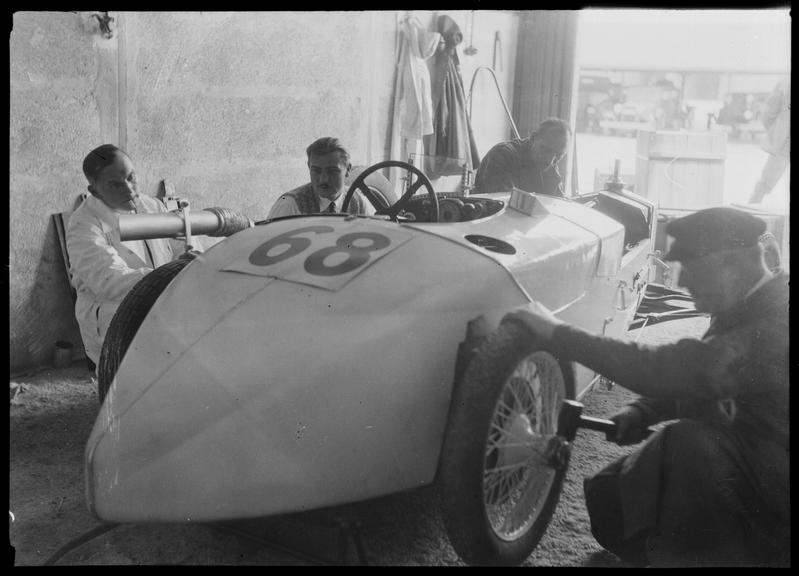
[552,272,790,565]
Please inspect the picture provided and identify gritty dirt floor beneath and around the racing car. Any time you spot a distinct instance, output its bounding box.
[9,318,707,567]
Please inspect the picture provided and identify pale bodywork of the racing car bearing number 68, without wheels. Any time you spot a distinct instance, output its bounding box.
[86,188,649,522]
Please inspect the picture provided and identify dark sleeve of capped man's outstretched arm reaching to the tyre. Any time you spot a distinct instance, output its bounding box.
[552,325,747,401]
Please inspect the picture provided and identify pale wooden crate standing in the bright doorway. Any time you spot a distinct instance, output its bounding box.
[635,130,727,210]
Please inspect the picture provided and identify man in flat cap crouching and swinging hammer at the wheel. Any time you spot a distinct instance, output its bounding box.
[505,207,790,566]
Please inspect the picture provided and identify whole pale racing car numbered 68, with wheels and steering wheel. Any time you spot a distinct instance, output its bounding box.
[85,161,657,564]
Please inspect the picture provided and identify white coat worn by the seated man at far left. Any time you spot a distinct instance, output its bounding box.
[66,195,176,364]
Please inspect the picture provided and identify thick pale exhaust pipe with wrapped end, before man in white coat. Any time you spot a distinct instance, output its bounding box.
[119,210,222,240]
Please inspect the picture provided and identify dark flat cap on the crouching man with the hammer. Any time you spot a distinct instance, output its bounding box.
[663,206,766,261]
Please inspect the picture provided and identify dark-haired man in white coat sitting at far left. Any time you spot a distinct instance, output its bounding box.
[66,144,183,364]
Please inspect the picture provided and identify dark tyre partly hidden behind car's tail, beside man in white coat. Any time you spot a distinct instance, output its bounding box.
[97,260,189,404]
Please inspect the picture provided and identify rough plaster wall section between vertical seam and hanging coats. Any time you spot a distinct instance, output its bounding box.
[123,12,394,220]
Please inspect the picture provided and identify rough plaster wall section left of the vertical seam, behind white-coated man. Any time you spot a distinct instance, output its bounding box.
[9,12,116,370]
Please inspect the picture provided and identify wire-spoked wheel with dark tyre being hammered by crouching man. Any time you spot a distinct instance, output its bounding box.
[438,322,574,565]
